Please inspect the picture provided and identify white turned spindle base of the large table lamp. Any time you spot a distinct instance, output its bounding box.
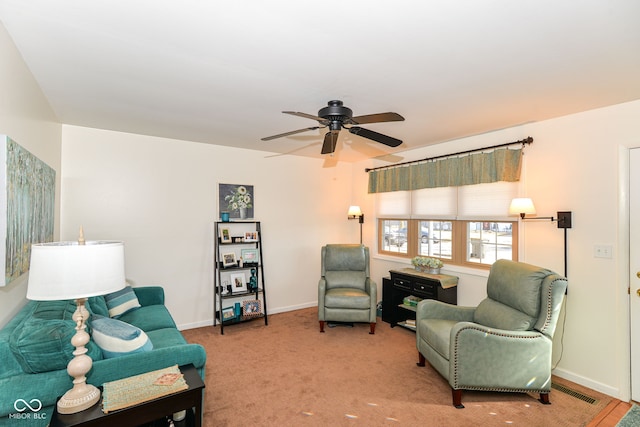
[58,298,100,414]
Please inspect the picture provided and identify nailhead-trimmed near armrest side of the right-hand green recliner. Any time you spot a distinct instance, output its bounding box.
[449,322,552,391]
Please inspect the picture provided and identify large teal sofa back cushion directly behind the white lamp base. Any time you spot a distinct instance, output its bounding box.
[9,301,102,374]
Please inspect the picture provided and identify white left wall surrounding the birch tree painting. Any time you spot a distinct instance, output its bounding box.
[0,25,61,327]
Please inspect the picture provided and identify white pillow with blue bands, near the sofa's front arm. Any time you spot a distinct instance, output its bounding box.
[91,316,153,359]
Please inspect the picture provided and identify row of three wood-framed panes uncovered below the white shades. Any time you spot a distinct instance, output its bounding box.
[378,219,518,268]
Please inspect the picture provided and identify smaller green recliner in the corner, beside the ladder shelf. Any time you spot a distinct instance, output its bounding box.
[318,244,378,334]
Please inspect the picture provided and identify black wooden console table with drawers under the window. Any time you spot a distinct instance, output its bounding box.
[382,268,458,331]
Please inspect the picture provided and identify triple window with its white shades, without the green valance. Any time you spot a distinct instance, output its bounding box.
[376,182,518,268]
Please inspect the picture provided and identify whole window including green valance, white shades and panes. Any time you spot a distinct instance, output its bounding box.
[369,149,523,268]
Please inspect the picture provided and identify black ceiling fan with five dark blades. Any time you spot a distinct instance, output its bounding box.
[262,100,404,154]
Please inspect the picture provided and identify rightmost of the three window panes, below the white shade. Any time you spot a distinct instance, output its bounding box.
[467,222,513,265]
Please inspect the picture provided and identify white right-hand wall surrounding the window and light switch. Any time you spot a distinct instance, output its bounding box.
[354,101,640,400]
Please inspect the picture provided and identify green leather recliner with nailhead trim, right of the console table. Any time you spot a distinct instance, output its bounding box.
[416,260,567,408]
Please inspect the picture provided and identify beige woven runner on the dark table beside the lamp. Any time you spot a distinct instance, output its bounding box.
[102,365,188,414]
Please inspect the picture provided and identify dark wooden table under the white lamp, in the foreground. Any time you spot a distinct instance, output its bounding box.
[50,364,204,427]
